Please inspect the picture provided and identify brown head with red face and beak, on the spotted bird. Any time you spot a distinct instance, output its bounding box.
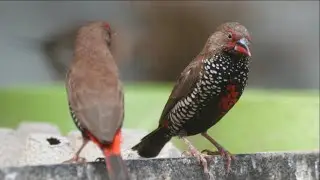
[207,22,251,57]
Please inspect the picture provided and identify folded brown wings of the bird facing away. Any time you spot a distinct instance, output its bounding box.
[66,67,124,143]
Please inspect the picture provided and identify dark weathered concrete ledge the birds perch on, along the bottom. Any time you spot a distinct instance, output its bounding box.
[0,151,319,180]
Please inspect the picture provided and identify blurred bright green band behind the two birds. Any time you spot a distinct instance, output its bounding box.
[0,83,319,153]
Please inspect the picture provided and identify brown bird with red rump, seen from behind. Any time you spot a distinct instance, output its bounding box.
[66,22,129,180]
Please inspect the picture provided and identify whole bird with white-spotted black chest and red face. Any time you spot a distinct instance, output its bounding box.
[132,22,251,175]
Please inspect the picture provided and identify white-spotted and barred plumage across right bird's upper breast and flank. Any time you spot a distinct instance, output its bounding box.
[165,54,249,135]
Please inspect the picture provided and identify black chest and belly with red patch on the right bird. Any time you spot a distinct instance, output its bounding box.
[176,57,248,135]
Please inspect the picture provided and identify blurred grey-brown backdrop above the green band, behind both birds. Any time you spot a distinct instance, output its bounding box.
[0,1,319,88]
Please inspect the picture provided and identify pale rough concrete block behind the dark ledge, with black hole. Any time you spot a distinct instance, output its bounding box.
[0,122,181,167]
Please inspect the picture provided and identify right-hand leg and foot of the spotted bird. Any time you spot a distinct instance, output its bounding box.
[201,132,235,172]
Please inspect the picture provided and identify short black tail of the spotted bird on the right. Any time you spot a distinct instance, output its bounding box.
[131,128,171,158]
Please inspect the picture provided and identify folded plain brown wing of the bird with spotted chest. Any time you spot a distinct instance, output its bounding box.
[159,56,203,125]
